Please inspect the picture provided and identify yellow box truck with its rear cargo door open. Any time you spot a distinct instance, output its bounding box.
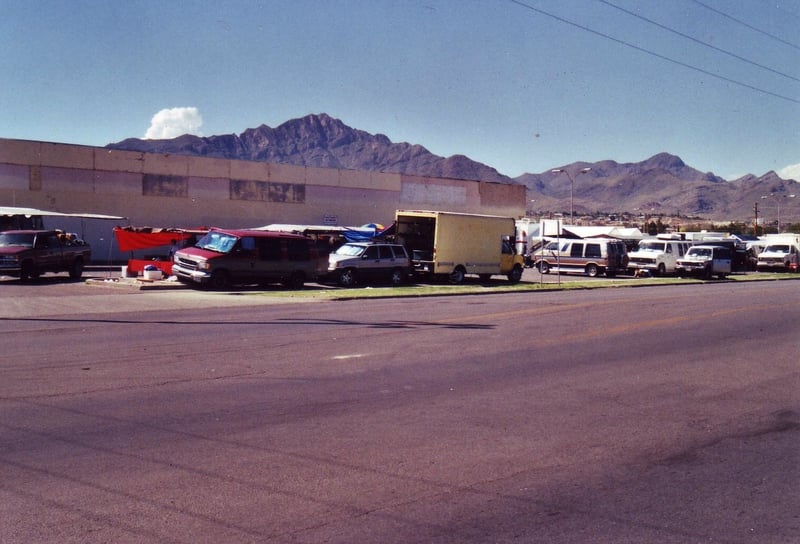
[395,210,524,283]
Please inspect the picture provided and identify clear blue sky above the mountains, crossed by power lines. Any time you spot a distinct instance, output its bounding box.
[0,0,800,179]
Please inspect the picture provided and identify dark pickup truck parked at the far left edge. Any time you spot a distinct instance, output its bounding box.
[0,230,92,281]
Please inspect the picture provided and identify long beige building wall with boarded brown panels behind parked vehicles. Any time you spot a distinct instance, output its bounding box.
[0,139,526,257]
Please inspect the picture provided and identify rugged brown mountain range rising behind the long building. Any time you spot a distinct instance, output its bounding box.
[106,113,799,221]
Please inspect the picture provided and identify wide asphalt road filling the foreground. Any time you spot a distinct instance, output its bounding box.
[0,281,800,544]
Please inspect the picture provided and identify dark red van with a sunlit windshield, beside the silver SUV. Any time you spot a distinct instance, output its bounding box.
[172,229,327,289]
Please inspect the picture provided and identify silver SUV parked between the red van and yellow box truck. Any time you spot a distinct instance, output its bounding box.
[328,242,412,287]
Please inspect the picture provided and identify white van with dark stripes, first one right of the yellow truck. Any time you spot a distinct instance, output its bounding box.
[533,238,628,278]
